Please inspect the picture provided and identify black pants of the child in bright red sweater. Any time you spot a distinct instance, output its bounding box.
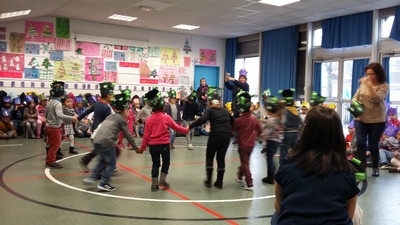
[149,144,171,177]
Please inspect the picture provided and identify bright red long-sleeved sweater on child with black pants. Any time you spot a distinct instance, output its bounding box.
[141,111,189,149]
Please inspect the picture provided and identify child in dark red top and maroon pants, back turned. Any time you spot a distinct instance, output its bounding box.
[232,91,262,191]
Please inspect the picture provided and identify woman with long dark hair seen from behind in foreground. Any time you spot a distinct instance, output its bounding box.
[271,106,359,225]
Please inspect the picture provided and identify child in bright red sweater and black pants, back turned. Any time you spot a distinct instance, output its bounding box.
[138,88,189,191]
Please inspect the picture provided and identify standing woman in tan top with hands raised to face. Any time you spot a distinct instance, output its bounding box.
[352,62,389,177]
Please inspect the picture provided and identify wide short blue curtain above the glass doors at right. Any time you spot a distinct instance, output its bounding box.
[321,11,372,48]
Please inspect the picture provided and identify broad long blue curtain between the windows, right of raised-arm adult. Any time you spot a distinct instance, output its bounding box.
[261,26,297,96]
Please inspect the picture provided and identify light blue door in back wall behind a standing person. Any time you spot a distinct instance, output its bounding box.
[194,65,219,91]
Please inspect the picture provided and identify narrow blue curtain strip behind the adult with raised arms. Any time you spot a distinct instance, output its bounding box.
[223,38,237,104]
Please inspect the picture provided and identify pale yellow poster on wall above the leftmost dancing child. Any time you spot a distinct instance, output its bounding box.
[54,56,83,81]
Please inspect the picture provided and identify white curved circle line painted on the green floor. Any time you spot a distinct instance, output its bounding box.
[45,153,275,203]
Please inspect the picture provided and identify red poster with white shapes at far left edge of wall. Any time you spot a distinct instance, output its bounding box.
[0,52,24,78]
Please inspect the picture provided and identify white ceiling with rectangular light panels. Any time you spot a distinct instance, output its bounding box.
[0,0,400,38]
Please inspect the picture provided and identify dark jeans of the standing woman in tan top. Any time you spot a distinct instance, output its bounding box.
[354,120,385,169]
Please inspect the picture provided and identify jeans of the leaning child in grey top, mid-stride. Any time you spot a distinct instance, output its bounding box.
[90,144,117,184]
